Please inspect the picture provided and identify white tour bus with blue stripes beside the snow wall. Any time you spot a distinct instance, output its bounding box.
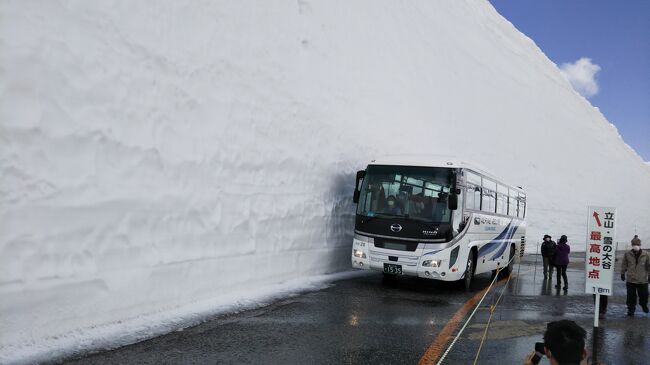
[352,157,526,288]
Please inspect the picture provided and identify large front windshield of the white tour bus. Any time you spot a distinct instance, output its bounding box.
[357,165,452,223]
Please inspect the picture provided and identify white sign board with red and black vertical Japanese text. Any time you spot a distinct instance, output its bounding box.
[585,207,616,295]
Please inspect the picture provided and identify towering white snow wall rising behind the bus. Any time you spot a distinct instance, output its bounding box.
[0,0,650,362]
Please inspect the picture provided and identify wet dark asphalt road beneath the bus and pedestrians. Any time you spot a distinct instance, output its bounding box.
[60,254,650,364]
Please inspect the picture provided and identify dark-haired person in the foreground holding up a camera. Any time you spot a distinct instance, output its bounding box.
[524,319,604,365]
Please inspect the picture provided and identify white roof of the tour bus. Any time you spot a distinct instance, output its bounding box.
[369,155,524,192]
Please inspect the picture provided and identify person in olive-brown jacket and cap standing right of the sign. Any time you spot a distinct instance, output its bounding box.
[621,235,650,317]
